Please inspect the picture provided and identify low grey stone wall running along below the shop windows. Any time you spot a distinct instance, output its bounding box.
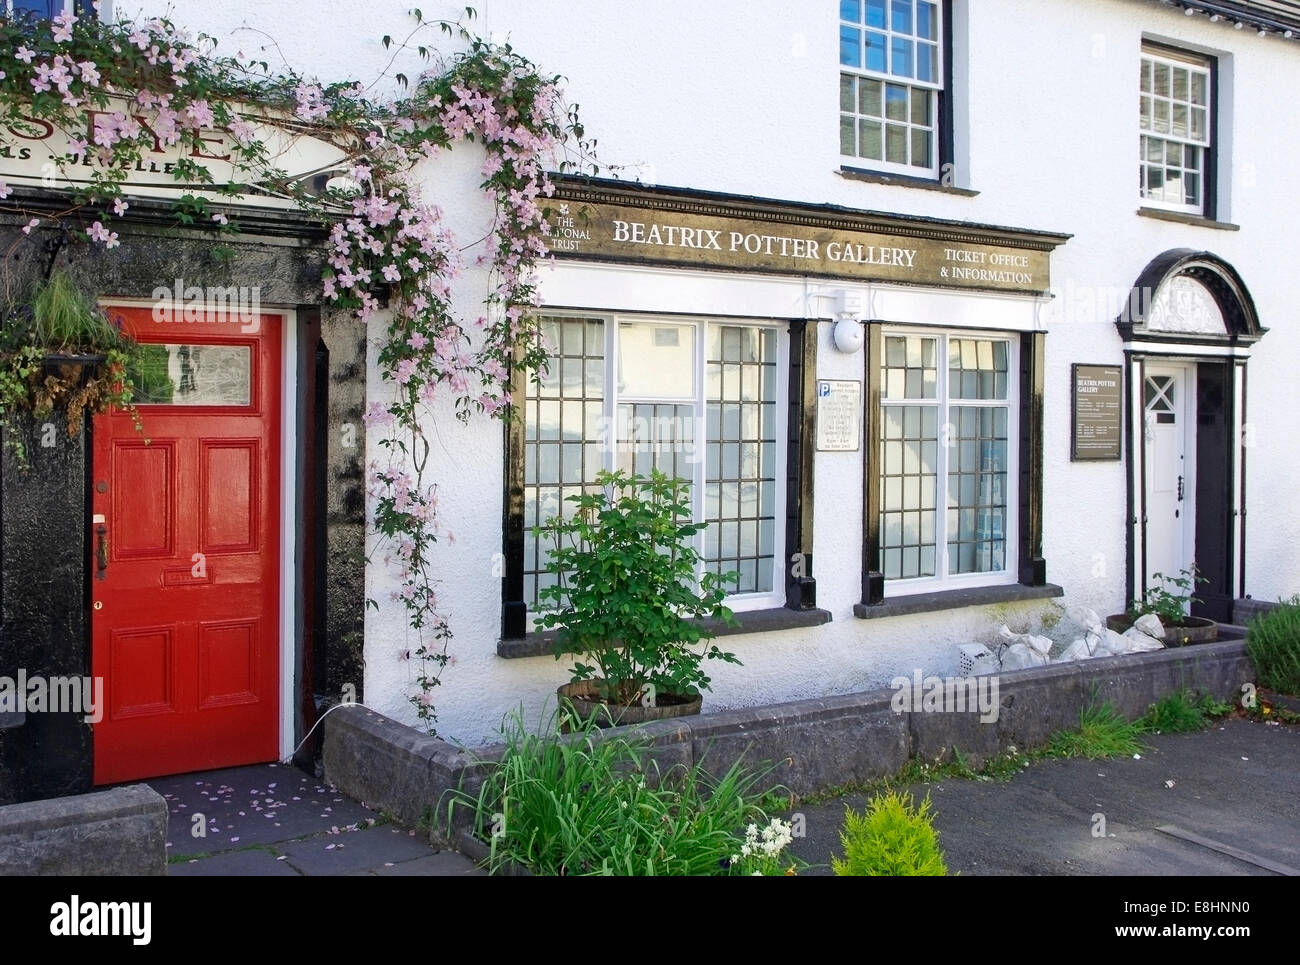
[324,640,1253,843]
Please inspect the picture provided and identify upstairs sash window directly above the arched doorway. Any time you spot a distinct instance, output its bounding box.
[1138,44,1214,217]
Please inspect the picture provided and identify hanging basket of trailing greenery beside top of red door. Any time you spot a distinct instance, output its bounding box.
[0,271,143,466]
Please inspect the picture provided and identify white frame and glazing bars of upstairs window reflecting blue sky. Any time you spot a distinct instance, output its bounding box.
[836,0,950,179]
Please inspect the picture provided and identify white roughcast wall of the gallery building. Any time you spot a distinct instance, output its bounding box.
[129,0,1300,743]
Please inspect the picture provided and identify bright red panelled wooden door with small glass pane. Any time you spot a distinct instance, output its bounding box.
[90,308,282,784]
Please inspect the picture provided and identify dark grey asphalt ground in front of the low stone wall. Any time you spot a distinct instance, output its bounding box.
[793,718,1300,875]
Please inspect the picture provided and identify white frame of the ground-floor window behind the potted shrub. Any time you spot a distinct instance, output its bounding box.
[525,308,790,623]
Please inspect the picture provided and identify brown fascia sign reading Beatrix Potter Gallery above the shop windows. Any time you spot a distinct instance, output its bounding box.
[549,198,1060,294]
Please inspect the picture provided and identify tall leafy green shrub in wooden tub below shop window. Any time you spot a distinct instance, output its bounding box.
[536,471,740,724]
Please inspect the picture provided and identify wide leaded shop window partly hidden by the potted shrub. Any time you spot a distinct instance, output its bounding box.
[523,316,787,619]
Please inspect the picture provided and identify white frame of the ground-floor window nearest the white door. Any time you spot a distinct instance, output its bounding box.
[871,325,1021,600]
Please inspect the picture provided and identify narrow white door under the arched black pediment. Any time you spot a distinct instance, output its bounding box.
[1143,363,1196,600]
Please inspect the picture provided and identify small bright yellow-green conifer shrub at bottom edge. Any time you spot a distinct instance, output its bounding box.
[831,791,948,875]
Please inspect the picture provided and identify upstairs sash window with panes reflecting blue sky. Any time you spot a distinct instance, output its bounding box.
[840,0,944,178]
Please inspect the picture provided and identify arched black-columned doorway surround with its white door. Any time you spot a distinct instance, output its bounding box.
[1115,248,1268,622]
